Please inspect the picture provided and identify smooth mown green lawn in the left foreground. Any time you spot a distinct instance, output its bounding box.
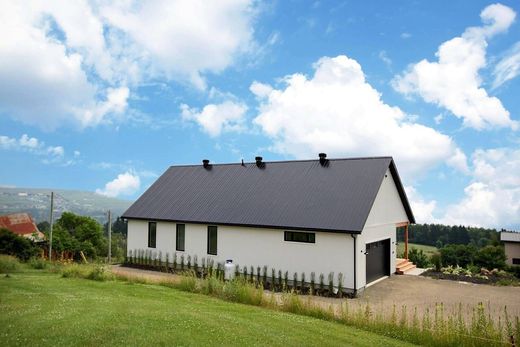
[0,271,414,346]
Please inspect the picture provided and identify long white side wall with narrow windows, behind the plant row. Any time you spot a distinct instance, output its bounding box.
[128,220,354,288]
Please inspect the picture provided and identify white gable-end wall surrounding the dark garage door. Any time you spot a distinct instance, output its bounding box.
[356,170,408,289]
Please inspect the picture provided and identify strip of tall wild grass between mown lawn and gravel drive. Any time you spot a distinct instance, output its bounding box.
[62,265,520,346]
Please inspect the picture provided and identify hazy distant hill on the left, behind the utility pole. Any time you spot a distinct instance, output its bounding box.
[0,187,133,223]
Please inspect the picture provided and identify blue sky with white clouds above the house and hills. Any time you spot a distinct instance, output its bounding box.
[0,0,520,229]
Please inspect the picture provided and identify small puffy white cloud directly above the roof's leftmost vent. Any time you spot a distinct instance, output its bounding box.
[181,101,247,137]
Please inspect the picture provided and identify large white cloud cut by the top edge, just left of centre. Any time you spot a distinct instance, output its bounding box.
[101,0,254,89]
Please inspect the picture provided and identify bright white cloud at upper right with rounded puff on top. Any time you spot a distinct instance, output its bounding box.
[392,4,518,130]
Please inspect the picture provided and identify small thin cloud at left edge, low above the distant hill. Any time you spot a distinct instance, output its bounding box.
[0,134,65,164]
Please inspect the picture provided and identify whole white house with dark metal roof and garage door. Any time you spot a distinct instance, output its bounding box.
[123,153,415,293]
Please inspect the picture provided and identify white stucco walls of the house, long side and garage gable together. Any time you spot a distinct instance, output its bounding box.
[128,171,408,289]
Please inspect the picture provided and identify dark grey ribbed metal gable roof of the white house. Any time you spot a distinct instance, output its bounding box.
[123,157,415,233]
